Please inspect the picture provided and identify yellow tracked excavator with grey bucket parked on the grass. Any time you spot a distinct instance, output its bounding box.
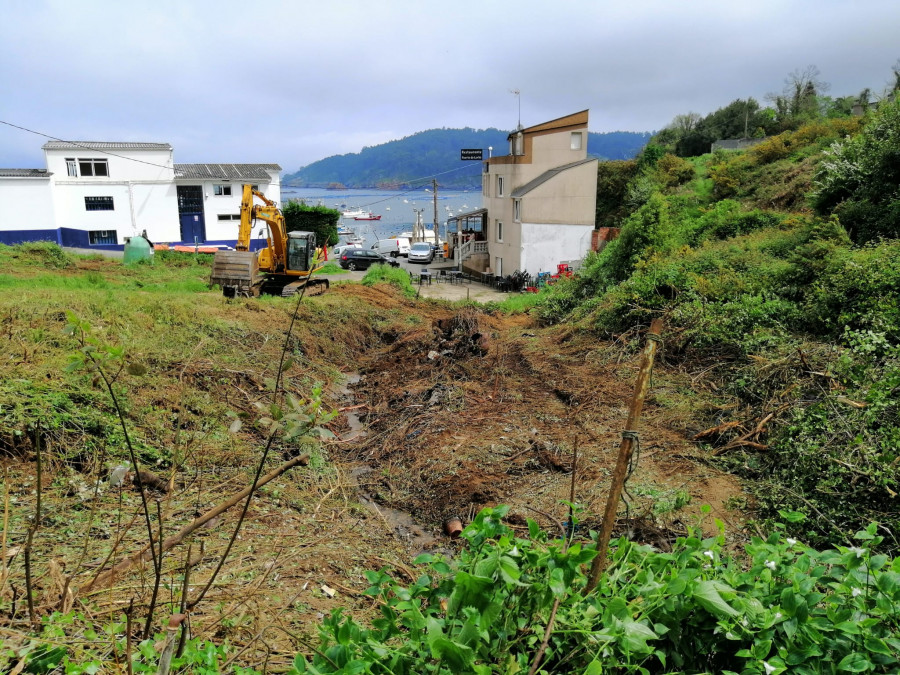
[209,185,328,298]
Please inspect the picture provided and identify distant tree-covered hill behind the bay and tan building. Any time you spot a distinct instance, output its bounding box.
[282,127,652,188]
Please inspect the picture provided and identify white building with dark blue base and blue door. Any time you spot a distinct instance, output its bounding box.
[0,141,281,248]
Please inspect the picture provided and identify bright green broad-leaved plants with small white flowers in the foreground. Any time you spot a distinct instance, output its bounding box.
[291,506,900,675]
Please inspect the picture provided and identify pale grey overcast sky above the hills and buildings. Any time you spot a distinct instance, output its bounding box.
[0,0,900,171]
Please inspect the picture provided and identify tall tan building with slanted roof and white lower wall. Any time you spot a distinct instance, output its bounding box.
[472,110,597,275]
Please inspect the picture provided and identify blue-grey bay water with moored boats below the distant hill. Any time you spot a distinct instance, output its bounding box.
[281,186,481,248]
